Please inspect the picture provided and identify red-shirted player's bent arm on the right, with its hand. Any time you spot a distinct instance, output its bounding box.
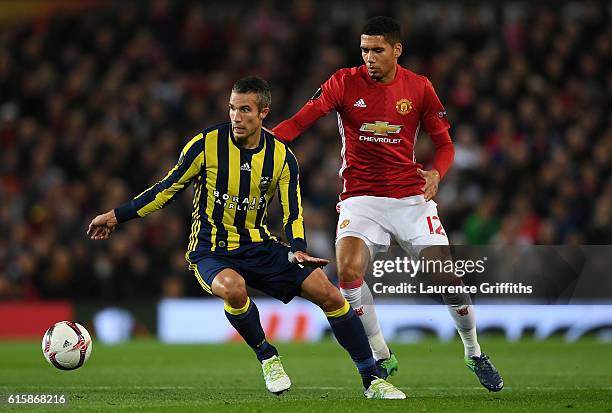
[417,80,455,201]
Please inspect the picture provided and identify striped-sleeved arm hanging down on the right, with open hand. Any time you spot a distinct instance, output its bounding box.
[278,148,329,267]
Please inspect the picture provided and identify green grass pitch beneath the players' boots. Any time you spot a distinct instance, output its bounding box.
[0,337,612,413]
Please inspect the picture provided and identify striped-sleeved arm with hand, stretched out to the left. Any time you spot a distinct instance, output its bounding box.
[87,134,204,240]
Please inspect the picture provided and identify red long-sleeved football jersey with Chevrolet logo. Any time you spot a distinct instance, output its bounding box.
[274,65,454,199]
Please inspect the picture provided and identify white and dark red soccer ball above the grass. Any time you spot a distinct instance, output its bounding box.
[42,321,92,370]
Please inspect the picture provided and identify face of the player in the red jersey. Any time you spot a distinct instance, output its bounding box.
[360,34,402,82]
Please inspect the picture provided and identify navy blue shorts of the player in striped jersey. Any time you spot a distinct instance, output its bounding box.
[189,240,314,304]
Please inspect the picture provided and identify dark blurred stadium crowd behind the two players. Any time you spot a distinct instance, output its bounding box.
[0,0,612,300]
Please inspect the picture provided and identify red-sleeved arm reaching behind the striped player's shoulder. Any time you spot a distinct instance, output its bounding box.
[272,70,343,142]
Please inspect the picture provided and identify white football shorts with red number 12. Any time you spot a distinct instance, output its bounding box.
[336,195,448,259]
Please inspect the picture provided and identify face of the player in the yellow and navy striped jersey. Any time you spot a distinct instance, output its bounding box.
[229,92,270,139]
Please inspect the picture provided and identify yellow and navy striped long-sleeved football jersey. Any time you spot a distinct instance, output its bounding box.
[115,122,306,261]
